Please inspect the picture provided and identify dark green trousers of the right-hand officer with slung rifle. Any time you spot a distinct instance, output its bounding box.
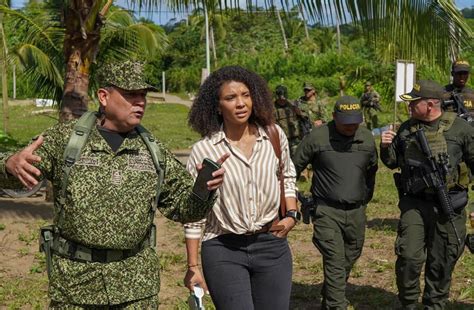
[395,197,466,310]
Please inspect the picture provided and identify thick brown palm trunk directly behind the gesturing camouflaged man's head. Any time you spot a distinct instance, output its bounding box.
[59,0,112,121]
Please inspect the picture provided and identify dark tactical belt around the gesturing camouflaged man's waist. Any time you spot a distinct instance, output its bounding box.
[52,236,150,263]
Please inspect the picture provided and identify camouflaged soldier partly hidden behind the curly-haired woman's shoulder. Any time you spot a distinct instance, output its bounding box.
[274,85,303,157]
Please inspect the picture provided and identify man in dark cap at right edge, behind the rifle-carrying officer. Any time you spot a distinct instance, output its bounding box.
[444,60,474,122]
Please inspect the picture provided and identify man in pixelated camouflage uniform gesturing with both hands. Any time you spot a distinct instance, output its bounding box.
[0,61,225,309]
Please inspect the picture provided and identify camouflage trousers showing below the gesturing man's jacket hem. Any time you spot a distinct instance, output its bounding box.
[49,295,159,310]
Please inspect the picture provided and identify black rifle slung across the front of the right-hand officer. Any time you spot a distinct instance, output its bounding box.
[415,128,462,245]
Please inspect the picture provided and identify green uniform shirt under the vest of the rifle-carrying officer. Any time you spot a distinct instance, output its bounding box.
[380,113,474,177]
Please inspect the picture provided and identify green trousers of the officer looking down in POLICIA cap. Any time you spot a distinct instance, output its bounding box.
[313,200,366,310]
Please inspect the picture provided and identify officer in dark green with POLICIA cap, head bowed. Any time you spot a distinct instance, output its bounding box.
[293,96,377,309]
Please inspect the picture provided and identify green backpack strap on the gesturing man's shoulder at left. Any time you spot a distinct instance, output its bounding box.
[57,111,97,228]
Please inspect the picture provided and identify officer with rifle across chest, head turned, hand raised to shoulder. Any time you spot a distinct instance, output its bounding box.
[380,80,474,310]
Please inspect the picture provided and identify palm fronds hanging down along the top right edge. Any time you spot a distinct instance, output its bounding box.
[167,0,473,67]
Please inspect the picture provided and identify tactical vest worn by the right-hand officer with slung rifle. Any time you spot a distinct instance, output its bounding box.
[402,112,469,194]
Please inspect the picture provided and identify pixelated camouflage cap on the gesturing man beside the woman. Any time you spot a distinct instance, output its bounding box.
[97,60,157,91]
